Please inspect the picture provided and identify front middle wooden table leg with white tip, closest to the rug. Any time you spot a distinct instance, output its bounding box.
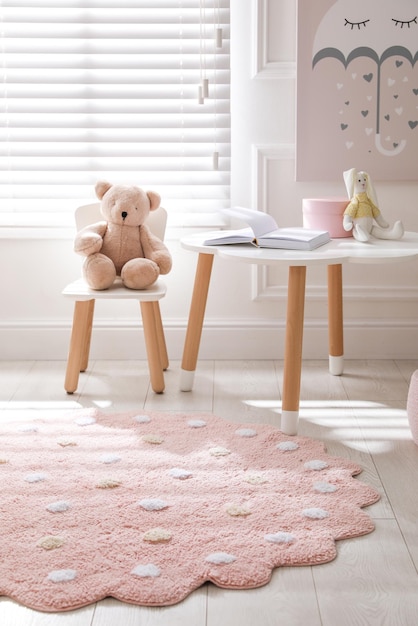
[281,265,306,435]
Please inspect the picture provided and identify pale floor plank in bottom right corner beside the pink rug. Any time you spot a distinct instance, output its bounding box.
[313,520,418,626]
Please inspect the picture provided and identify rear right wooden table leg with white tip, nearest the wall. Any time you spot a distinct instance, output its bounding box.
[328,264,344,376]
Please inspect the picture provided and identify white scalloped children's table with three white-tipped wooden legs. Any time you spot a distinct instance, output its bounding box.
[180,232,418,435]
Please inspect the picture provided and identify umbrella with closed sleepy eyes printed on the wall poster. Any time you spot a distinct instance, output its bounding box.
[312,0,418,156]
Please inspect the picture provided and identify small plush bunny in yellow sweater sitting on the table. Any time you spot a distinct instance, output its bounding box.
[343,168,404,242]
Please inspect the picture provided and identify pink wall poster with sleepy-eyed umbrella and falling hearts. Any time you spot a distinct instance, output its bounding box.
[296,0,418,181]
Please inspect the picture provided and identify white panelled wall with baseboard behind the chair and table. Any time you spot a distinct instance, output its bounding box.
[0,0,418,360]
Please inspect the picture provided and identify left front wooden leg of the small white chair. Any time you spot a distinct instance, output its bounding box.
[64,300,94,393]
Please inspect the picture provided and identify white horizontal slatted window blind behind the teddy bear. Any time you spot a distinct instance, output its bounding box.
[0,0,230,213]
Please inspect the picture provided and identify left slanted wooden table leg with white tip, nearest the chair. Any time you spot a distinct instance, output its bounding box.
[180,252,214,391]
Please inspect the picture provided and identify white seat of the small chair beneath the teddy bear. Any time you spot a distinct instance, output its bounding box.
[62,278,167,302]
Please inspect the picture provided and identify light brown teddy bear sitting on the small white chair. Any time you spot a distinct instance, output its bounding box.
[74,181,172,290]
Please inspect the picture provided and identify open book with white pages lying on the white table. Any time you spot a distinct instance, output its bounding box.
[203,207,330,250]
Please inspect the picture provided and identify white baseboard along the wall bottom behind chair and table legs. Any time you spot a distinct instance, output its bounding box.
[0,318,418,360]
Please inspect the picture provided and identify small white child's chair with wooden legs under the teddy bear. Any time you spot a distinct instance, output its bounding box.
[62,202,168,393]
